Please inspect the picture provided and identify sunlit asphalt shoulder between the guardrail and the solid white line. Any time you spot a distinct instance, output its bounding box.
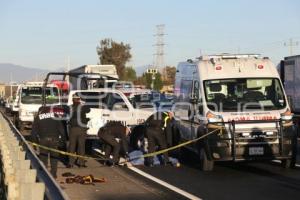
[0,109,186,200]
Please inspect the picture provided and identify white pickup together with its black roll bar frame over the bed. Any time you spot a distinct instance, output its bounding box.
[43,72,154,139]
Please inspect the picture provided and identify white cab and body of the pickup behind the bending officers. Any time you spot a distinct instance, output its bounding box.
[68,88,154,139]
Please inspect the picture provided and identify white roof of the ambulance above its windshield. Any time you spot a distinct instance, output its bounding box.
[178,54,279,80]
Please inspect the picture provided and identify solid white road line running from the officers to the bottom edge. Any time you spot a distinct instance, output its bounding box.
[128,166,202,200]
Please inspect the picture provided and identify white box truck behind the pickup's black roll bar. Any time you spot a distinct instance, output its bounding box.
[69,65,119,90]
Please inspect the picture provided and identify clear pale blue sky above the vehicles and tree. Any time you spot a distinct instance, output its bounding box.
[0,0,300,70]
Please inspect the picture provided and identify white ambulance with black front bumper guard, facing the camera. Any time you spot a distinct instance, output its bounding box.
[174,54,297,171]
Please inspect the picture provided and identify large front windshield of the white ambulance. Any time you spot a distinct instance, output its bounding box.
[204,78,286,112]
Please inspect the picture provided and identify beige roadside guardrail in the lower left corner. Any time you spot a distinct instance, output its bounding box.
[0,113,69,200]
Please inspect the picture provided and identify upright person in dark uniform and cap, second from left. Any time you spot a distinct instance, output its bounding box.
[67,95,89,168]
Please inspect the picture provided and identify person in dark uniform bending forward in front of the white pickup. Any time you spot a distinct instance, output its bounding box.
[98,121,130,165]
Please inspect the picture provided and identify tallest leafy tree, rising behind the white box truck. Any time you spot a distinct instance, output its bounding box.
[97,38,131,79]
